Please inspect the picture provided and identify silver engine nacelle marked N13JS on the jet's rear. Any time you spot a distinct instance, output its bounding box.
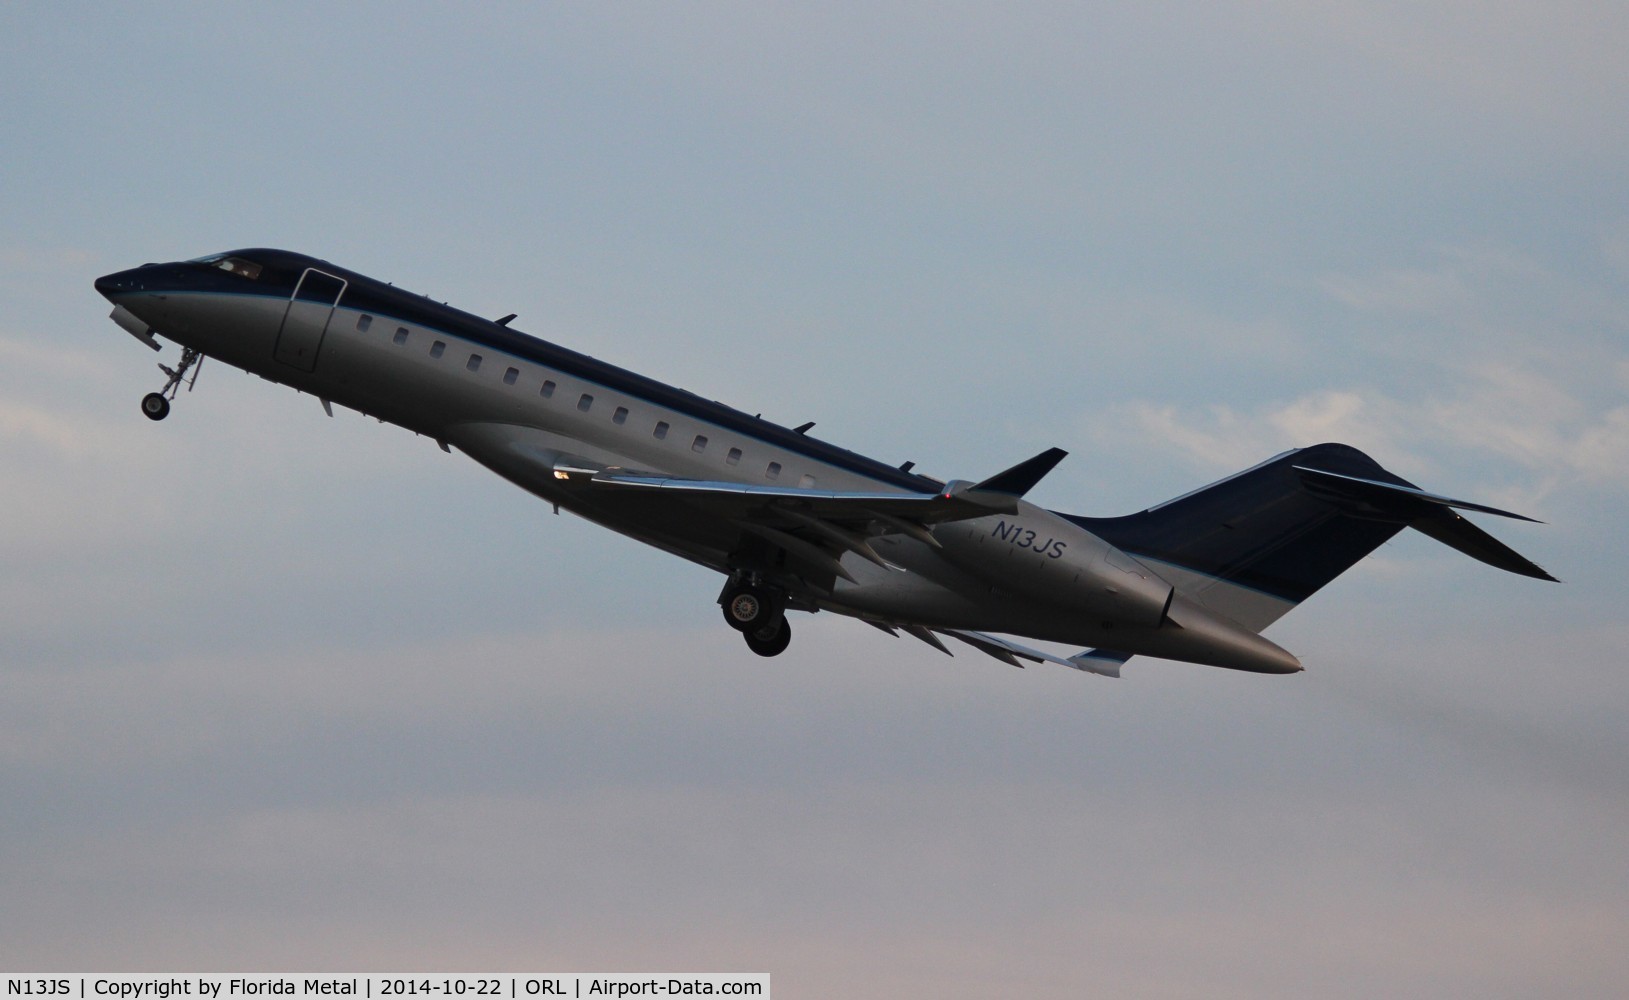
[933,502,1173,627]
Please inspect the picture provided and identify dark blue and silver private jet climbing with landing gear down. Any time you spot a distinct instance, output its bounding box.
[96,249,1554,676]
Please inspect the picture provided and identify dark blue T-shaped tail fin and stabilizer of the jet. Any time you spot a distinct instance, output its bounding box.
[1062,445,1556,661]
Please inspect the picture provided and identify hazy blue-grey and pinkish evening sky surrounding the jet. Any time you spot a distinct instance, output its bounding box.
[0,0,1629,998]
